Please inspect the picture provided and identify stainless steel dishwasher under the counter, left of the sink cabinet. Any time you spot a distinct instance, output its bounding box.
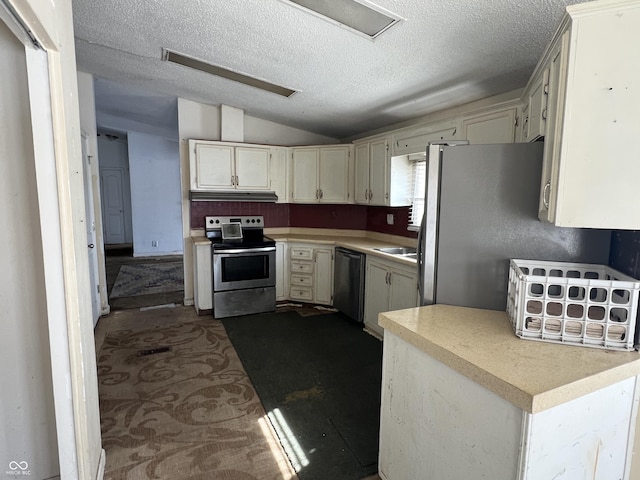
[333,247,365,322]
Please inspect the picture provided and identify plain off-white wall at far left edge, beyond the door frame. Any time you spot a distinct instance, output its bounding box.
[0,17,60,479]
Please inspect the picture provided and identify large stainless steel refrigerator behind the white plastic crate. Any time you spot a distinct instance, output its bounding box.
[418,143,611,310]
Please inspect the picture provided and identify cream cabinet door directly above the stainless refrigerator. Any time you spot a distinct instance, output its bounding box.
[462,108,516,145]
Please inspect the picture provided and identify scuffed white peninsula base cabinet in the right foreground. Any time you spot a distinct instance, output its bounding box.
[379,332,638,480]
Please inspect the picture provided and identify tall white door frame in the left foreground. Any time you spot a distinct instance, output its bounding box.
[0,0,105,480]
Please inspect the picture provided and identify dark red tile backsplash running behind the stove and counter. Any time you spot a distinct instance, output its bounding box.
[191,201,416,238]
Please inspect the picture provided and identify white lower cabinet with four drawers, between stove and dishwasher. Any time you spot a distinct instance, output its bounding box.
[288,243,333,305]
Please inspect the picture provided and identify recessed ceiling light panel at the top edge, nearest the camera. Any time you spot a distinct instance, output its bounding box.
[282,0,402,38]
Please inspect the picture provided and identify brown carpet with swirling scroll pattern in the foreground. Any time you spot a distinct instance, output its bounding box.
[98,318,297,480]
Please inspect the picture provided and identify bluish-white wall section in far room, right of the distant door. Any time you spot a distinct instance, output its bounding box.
[128,132,183,256]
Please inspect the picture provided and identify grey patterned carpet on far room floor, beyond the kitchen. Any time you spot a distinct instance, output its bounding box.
[109,261,184,298]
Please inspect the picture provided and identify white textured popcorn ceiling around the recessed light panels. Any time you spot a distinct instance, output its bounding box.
[73,0,580,138]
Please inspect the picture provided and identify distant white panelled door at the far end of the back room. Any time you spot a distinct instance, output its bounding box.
[100,167,126,244]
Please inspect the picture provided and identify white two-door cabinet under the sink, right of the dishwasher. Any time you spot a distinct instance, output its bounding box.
[364,256,418,336]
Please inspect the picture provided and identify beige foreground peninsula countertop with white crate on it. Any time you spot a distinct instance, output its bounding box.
[378,305,640,413]
